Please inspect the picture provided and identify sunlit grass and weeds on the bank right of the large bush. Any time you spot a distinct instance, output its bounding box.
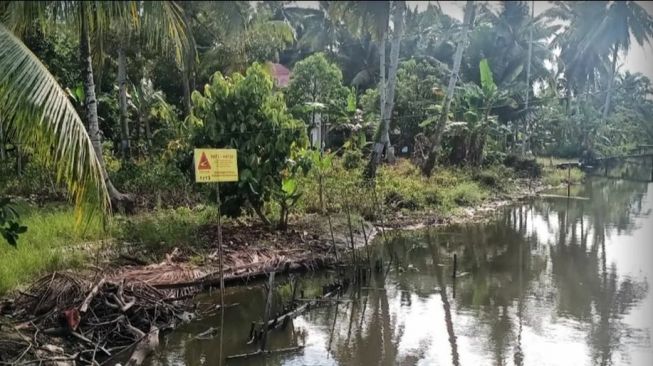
[295,159,500,219]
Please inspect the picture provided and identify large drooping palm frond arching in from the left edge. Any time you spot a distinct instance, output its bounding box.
[0,25,109,220]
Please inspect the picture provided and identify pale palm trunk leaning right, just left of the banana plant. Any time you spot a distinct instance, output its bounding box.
[422,0,476,176]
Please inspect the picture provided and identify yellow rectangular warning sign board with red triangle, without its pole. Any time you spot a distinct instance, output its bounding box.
[193,149,238,183]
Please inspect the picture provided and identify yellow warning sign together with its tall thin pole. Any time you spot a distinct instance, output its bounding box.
[193,149,238,365]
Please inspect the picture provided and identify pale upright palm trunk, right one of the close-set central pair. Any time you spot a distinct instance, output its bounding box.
[383,1,406,163]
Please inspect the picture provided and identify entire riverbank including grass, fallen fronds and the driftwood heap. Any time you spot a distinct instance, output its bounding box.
[0,161,582,359]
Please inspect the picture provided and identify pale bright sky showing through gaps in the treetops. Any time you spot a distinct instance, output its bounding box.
[284,1,653,80]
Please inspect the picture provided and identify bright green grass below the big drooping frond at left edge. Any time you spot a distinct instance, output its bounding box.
[0,204,107,295]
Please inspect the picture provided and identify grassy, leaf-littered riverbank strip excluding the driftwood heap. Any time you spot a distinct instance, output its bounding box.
[0,159,583,295]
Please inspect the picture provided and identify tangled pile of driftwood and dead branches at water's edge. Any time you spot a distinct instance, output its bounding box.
[0,272,190,365]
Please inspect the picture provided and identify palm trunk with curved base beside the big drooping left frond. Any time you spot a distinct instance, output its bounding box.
[79,1,125,201]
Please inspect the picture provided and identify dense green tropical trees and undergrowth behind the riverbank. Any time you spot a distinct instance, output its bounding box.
[0,1,653,290]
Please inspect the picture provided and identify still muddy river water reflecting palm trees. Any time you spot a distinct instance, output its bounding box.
[148,164,653,366]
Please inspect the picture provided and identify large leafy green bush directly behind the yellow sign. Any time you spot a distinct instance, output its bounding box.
[191,64,307,226]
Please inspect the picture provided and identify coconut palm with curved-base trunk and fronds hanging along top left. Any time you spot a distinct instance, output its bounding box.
[4,1,195,210]
